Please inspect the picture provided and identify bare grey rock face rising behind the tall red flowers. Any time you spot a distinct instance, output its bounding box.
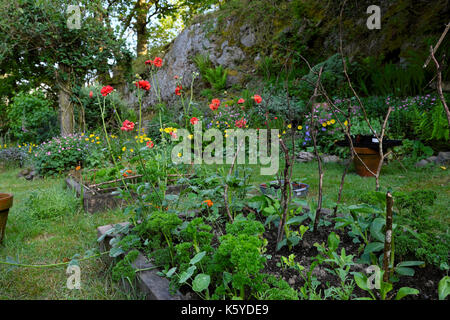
[144,20,251,107]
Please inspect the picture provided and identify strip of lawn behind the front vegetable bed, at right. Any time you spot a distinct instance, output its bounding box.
[241,161,450,225]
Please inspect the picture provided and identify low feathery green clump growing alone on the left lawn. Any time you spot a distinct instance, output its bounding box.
[24,186,79,220]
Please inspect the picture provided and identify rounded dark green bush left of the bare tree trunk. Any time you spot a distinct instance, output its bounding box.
[8,91,59,143]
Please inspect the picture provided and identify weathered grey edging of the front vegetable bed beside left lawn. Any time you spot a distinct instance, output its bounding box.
[97,222,188,300]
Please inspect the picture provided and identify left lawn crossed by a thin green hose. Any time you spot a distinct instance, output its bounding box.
[0,170,127,299]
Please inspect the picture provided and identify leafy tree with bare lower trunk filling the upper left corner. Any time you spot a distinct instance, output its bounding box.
[0,0,131,134]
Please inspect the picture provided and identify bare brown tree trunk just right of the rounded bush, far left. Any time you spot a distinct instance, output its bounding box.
[58,63,74,135]
